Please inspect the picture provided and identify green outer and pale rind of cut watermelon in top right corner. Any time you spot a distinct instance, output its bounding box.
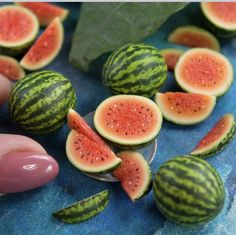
[200,3,236,38]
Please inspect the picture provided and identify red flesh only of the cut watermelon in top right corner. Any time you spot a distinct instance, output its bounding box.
[204,2,236,25]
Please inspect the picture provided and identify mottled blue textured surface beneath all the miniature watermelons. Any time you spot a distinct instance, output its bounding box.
[0,4,236,235]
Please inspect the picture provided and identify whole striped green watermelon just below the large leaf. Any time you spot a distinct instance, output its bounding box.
[103,44,167,97]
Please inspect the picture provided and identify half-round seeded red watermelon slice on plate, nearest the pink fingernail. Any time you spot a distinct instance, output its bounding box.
[66,130,121,173]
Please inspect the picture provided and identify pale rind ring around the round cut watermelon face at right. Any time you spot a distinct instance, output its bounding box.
[174,48,234,97]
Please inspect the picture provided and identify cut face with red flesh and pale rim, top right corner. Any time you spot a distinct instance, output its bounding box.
[201,2,236,31]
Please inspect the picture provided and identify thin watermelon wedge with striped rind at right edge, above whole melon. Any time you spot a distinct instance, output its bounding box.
[191,113,236,157]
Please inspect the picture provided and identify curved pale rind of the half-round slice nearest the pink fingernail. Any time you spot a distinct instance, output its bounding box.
[66,129,121,174]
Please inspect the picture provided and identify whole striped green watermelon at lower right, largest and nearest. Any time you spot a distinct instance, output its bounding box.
[153,156,225,226]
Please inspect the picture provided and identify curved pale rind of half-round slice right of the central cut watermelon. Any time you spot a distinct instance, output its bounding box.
[154,93,216,125]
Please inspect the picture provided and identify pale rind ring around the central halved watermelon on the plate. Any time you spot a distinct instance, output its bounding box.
[94,95,162,148]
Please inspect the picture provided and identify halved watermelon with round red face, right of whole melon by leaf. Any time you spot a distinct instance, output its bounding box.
[175,48,234,96]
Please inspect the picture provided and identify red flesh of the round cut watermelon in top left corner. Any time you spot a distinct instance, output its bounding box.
[0,7,35,43]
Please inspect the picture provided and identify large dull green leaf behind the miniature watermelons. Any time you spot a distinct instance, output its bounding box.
[70,2,187,71]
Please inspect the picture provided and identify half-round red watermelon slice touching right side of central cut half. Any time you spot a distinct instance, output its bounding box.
[155,92,216,125]
